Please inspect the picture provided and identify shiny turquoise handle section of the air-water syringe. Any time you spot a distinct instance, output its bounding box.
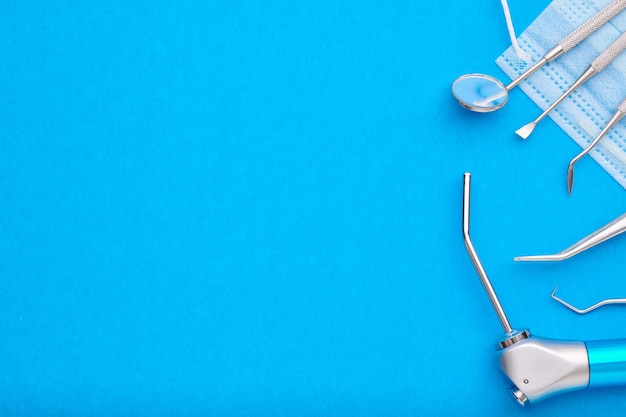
[585,339,626,388]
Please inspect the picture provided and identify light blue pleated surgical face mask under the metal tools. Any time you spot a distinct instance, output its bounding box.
[496,0,626,188]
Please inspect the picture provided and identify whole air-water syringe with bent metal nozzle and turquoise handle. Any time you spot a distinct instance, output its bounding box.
[463,173,626,406]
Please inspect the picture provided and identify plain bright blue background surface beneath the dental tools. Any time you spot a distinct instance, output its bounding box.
[0,0,626,416]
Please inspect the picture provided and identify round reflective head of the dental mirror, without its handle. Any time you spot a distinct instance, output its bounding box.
[452,74,509,113]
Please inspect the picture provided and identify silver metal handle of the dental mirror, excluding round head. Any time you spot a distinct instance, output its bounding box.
[505,0,626,91]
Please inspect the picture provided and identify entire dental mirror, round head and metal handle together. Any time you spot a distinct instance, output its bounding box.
[452,0,626,113]
